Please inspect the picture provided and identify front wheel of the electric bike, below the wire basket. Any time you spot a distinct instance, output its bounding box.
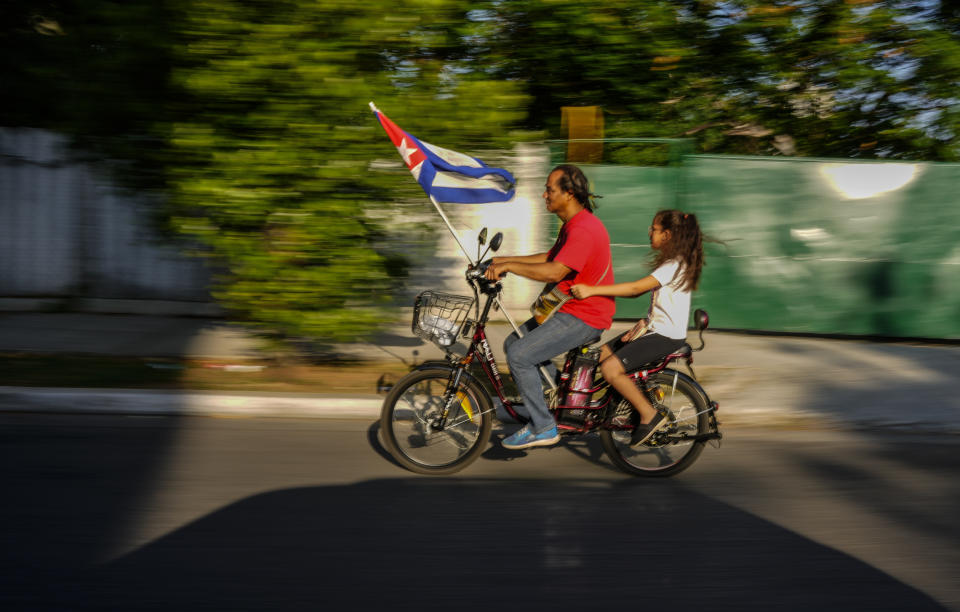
[380,369,493,475]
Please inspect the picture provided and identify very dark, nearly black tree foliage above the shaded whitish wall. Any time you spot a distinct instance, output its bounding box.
[0,0,174,173]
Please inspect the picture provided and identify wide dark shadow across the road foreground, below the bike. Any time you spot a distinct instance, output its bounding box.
[16,477,943,612]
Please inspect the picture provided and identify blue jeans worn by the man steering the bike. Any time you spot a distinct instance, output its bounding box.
[503,312,603,433]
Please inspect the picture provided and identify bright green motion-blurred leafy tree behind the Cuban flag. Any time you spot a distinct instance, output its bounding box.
[163,0,523,341]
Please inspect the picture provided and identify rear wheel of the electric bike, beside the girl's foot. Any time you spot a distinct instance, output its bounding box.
[600,370,709,476]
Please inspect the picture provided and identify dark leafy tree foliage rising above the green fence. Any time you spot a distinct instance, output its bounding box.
[487,0,960,160]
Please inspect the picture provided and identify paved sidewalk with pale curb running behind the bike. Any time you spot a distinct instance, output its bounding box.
[0,313,960,434]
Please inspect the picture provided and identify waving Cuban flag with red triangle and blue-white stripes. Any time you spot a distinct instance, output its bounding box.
[370,102,516,204]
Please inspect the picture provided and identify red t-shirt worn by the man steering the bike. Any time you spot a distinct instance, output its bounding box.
[547,209,616,329]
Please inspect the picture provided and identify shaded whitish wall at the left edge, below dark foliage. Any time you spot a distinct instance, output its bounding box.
[0,128,210,304]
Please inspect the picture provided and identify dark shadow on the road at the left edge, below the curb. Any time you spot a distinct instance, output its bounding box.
[0,414,183,610]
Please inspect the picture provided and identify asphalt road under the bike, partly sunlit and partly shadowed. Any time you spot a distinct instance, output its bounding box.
[0,414,960,612]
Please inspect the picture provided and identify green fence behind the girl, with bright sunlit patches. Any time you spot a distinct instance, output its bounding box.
[552,146,960,339]
